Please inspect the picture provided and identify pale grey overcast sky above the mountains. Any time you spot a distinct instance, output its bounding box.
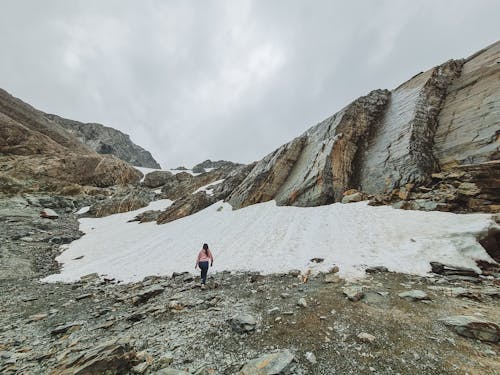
[0,0,500,167]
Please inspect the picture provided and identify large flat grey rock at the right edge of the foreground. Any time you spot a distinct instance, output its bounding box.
[439,315,500,342]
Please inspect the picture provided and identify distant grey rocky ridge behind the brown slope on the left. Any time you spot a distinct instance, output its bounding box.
[45,114,160,169]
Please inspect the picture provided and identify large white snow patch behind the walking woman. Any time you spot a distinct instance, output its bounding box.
[43,200,496,282]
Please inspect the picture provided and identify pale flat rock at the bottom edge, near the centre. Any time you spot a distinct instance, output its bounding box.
[239,349,295,375]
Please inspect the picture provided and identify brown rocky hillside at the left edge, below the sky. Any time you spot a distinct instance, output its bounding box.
[0,90,141,194]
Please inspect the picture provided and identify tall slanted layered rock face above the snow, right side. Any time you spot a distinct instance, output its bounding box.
[228,42,500,212]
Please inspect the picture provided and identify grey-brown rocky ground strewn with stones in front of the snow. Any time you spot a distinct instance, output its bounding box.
[0,197,500,375]
